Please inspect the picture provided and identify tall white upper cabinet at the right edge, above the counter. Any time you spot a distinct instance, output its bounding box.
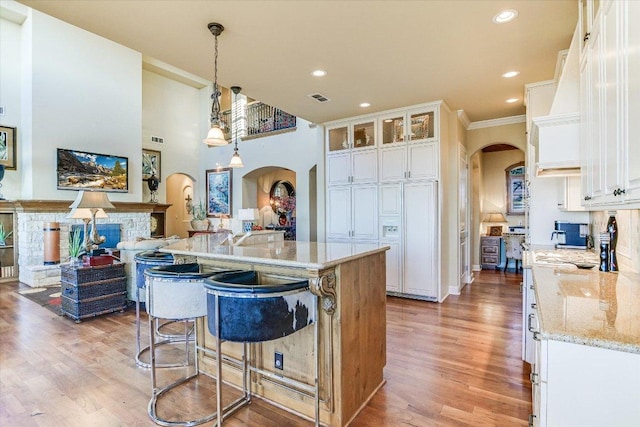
[580,0,640,207]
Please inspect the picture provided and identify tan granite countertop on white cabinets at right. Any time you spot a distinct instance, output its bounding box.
[532,263,640,354]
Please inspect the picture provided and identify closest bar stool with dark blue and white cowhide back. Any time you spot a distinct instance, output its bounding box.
[204,271,320,427]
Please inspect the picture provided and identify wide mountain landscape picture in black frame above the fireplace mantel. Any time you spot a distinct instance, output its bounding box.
[56,148,129,193]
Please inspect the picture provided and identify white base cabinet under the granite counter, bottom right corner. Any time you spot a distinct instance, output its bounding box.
[532,339,640,427]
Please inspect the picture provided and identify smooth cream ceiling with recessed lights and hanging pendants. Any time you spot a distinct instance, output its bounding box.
[20,0,578,123]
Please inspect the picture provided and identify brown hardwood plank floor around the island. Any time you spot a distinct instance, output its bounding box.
[0,271,531,427]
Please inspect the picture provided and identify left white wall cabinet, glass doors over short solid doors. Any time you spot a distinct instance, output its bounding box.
[327,120,378,185]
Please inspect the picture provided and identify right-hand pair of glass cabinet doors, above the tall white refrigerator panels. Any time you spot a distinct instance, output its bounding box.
[380,109,436,147]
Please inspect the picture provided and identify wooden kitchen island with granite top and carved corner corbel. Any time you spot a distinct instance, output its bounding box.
[160,235,388,426]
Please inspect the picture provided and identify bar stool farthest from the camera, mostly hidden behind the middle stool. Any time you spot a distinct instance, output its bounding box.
[134,251,193,368]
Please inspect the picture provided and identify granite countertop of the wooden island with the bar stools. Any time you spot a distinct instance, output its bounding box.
[159,235,389,270]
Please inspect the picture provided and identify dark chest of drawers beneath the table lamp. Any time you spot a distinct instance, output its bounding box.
[60,262,127,323]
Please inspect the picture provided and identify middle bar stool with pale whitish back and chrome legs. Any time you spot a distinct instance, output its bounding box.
[144,263,216,426]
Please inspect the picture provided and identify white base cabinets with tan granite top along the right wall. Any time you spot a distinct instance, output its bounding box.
[523,251,640,427]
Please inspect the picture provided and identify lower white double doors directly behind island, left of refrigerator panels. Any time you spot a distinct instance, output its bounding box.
[327,185,378,241]
